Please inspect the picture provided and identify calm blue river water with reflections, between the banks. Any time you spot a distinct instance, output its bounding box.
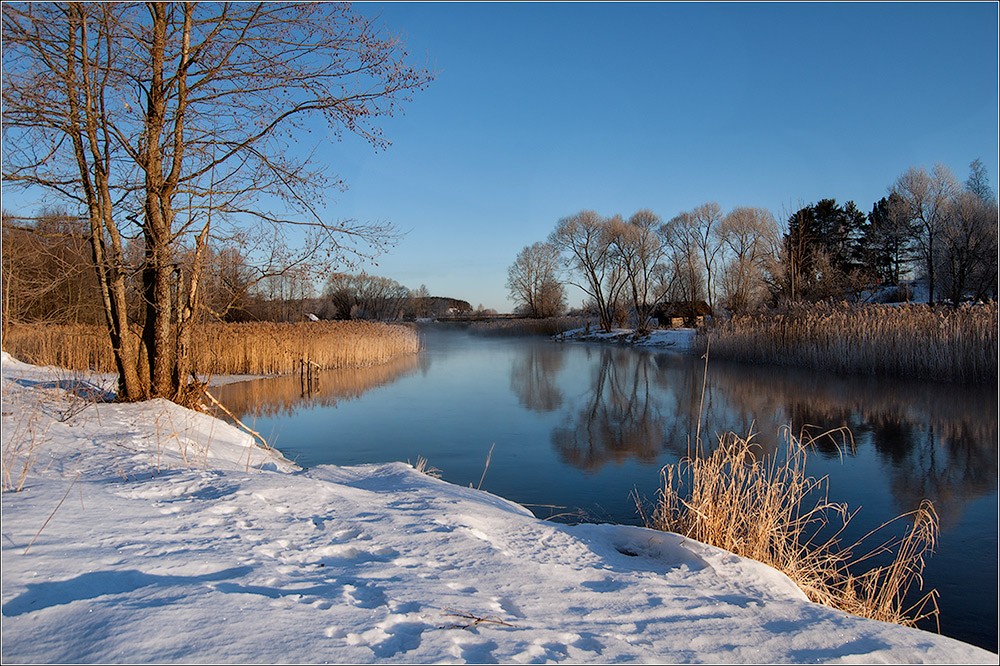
[217,328,998,652]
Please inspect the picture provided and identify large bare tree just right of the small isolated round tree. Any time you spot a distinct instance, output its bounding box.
[549,210,626,331]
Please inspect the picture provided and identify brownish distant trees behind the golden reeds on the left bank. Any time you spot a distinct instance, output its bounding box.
[2,209,473,332]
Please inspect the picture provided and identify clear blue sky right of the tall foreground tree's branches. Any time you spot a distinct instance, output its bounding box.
[3,2,998,311]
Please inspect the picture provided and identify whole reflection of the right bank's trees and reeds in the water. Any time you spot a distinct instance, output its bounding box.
[544,347,998,528]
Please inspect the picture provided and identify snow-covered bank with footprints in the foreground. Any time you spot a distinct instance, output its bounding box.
[0,355,997,663]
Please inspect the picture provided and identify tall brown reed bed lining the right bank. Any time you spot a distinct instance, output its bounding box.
[700,303,997,382]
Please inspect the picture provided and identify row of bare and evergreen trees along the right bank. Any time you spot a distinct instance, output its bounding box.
[507,159,997,330]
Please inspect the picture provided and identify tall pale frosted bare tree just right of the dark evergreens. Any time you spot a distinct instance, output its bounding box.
[890,164,958,304]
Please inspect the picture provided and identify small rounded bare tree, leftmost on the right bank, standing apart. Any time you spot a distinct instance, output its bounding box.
[507,243,566,318]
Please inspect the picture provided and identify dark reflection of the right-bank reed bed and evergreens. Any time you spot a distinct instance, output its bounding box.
[710,364,998,528]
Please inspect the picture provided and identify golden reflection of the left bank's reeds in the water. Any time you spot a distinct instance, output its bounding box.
[212,354,429,419]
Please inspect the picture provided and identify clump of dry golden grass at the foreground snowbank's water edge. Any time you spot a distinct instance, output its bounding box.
[646,426,938,626]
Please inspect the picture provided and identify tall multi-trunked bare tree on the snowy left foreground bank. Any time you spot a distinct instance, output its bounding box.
[3,3,431,402]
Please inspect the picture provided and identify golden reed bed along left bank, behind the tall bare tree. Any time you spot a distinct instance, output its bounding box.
[4,321,420,375]
